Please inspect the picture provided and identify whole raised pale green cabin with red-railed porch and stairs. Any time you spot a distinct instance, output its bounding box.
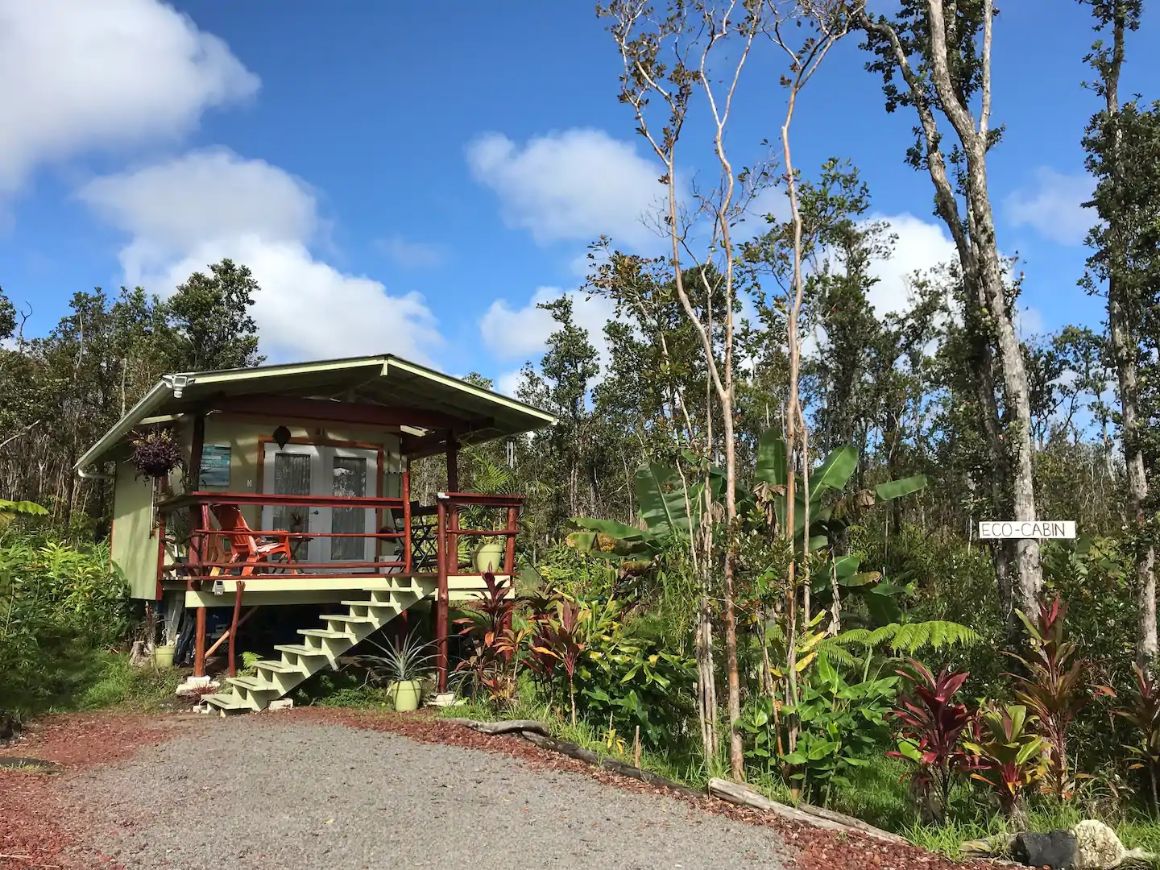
[77,354,554,711]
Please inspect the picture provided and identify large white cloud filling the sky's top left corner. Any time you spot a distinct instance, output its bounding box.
[0,0,259,193]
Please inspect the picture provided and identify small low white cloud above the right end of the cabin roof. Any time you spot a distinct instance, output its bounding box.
[479,287,616,368]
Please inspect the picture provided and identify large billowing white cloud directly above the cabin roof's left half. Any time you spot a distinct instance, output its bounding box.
[79,150,442,361]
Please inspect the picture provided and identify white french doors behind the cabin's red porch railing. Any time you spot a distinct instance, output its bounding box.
[262,443,379,571]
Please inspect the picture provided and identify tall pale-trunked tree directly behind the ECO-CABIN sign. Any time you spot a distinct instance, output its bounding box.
[856,0,1043,614]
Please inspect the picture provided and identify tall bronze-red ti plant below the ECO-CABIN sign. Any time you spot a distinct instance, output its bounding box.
[1010,596,1092,799]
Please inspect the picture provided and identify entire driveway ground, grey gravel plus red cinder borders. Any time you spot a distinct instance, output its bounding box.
[0,710,979,870]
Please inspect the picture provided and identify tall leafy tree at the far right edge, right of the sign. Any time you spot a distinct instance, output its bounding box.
[1081,0,1160,664]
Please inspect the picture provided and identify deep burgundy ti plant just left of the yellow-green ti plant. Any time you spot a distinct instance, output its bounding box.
[886,659,974,821]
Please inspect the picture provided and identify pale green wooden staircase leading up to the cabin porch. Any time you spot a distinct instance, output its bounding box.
[202,577,434,716]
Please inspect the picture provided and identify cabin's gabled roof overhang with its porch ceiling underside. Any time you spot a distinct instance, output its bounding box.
[77,354,556,472]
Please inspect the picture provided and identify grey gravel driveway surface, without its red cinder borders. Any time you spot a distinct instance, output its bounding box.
[67,716,784,870]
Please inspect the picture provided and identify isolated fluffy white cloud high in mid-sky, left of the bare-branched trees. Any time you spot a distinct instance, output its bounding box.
[467,129,664,248]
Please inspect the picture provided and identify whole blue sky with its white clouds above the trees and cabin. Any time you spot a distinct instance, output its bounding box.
[0,0,1160,394]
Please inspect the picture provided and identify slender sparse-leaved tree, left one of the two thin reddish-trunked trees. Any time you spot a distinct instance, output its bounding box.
[599,0,768,778]
